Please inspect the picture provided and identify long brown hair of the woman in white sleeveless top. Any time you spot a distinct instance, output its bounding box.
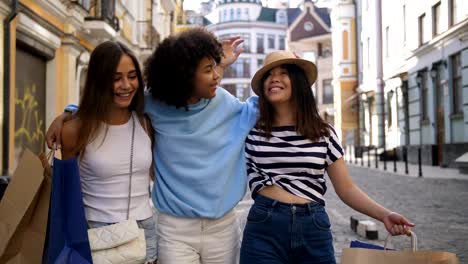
[76,41,144,152]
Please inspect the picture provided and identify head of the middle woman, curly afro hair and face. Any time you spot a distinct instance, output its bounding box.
[144,29,226,108]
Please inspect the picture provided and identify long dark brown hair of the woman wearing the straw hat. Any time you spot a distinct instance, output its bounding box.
[257,64,330,141]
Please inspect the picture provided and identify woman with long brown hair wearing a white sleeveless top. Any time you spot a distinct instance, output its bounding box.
[61,41,157,263]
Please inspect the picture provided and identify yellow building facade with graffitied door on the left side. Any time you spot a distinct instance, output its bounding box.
[0,0,175,175]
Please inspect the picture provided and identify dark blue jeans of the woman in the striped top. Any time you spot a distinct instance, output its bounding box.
[240,195,336,264]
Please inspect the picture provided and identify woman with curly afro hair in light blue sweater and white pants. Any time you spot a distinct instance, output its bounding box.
[144,29,258,263]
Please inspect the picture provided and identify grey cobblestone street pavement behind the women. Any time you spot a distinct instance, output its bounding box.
[236,165,468,263]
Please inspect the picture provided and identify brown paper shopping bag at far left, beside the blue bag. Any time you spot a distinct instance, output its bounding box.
[0,149,51,264]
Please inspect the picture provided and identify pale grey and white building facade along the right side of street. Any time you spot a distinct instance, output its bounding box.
[357,0,468,167]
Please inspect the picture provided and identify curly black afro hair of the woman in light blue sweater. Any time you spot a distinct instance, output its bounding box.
[144,28,223,108]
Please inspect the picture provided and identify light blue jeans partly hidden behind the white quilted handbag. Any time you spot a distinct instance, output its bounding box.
[88,216,158,262]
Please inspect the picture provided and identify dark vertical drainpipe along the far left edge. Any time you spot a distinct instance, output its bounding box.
[2,0,18,175]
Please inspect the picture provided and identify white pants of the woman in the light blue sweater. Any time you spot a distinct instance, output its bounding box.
[157,210,240,264]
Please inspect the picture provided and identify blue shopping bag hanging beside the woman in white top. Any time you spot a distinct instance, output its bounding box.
[44,158,93,264]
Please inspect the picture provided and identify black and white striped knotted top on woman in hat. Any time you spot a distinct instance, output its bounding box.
[245,126,343,205]
